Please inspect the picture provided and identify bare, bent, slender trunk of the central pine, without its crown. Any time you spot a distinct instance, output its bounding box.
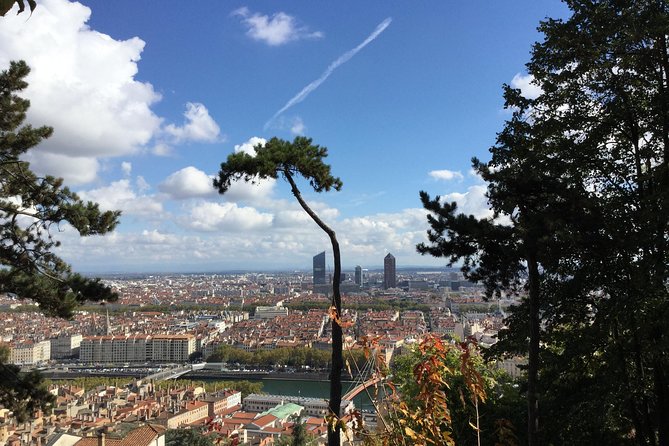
[283,170,344,446]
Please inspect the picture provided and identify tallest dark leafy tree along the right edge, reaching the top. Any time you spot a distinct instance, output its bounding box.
[528,0,669,445]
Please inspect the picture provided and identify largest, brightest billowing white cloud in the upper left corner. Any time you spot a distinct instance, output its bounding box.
[0,0,161,181]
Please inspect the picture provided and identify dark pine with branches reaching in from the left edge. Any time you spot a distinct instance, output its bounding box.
[0,62,120,417]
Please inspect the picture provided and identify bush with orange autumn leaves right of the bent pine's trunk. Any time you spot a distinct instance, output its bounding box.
[374,336,523,445]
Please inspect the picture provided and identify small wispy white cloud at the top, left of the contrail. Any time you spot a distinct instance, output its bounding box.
[232,7,323,46]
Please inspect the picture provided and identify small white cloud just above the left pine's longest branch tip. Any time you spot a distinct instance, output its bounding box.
[79,179,163,217]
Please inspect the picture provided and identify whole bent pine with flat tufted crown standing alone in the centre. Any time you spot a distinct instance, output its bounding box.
[214,136,344,446]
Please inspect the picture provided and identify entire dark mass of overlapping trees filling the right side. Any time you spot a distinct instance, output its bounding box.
[419,0,669,445]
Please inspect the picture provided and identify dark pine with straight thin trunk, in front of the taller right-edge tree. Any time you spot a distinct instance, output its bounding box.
[417,87,583,445]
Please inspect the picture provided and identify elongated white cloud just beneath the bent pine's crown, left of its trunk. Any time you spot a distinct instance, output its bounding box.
[182,202,272,232]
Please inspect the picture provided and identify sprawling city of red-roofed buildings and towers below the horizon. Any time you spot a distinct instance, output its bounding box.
[0,252,523,444]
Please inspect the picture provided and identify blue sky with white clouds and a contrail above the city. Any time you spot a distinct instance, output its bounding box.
[0,0,568,273]
